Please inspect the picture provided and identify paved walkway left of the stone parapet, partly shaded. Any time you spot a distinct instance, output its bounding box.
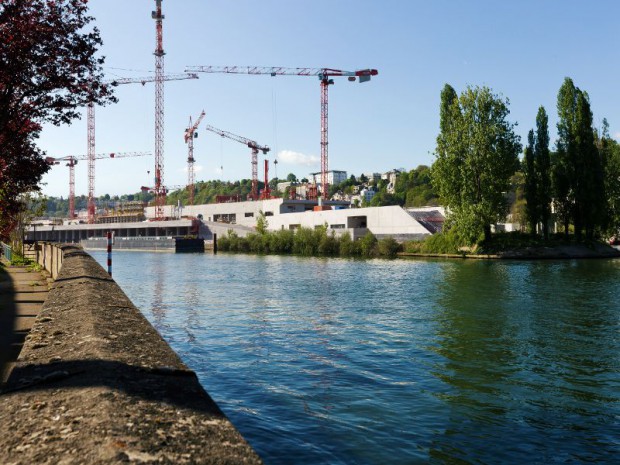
[0,265,49,385]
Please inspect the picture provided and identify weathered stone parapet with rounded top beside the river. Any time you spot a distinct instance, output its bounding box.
[0,246,261,464]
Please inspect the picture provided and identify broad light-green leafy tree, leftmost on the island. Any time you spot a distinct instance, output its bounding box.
[432,86,521,242]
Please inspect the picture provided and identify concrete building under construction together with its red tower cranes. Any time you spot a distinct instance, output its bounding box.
[27,0,443,250]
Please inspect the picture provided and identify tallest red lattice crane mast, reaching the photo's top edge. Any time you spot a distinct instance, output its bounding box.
[151,0,166,220]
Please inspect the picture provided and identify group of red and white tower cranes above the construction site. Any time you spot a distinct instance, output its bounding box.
[48,0,378,223]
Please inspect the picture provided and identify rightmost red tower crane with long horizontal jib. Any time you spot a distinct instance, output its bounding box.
[185,66,379,200]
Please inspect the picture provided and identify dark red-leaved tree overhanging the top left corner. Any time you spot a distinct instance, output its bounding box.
[0,0,115,238]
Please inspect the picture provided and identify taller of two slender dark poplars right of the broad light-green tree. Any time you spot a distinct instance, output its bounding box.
[534,106,552,239]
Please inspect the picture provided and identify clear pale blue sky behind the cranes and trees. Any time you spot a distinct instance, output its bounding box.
[39,0,620,197]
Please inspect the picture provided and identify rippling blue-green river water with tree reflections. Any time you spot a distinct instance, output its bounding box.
[92,252,620,465]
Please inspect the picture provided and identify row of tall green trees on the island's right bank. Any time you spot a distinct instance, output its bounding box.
[420,78,620,252]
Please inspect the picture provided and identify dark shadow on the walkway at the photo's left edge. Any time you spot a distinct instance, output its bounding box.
[0,264,17,386]
